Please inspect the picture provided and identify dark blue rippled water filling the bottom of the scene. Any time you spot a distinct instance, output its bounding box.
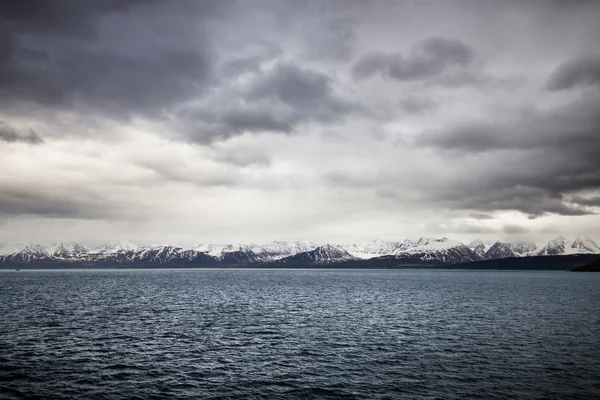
[0,270,600,399]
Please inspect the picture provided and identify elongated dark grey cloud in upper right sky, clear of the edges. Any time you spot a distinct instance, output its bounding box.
[352,37,475,81]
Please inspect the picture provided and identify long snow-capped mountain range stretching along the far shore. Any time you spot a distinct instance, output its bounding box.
[0,236,600,267]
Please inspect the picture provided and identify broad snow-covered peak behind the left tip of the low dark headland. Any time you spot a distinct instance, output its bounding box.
[394,238,481,264]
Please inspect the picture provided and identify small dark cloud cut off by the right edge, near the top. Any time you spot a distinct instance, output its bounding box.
[546,55,600,91]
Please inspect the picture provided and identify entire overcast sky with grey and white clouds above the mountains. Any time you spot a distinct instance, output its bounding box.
[0,0,600,245]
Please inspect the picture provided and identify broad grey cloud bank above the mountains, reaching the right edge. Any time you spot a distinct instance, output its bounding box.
[416,95,600,217]
